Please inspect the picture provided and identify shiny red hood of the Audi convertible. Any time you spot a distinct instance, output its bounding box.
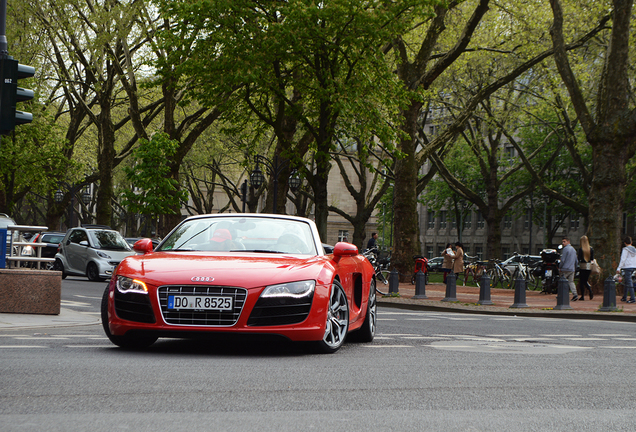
[117,252,331,288]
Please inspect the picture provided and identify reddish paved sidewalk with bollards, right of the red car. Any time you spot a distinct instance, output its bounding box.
[378,283,636,322]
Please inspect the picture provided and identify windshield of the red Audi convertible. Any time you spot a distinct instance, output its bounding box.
[157,217,316,255]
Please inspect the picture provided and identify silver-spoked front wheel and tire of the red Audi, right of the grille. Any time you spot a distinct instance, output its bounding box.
[314,280,349,354]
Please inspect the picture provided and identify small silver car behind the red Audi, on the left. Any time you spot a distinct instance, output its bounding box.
[53,225,136,281]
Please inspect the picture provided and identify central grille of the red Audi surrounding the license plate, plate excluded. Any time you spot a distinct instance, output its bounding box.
[158,285,247,326]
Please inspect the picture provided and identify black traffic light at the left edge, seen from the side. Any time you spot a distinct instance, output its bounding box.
[0,56,35,135]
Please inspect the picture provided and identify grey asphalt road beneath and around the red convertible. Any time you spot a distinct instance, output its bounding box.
[0,278,636,431]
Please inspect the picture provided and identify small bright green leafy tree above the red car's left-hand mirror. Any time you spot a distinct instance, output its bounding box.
[123,133,188,216]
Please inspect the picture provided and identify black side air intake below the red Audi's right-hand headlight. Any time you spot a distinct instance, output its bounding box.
[247,293,313,326]
